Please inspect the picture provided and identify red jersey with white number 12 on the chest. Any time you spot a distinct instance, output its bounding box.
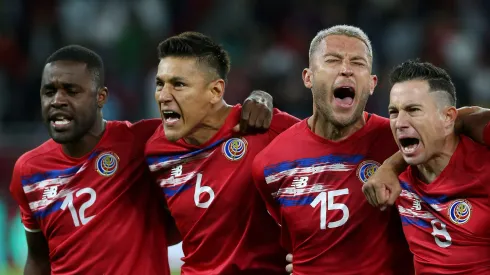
[10,120,170,275]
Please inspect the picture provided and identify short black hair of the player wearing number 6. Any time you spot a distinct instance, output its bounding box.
[157,32,230,81]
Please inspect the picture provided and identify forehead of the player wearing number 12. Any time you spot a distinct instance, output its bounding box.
[42,60,93,86]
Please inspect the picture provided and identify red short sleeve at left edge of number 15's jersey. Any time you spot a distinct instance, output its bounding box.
[252,154,281,224]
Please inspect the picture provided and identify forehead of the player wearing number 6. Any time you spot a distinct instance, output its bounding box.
[157,57,204,81]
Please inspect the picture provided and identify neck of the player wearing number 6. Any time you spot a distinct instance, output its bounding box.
[184,102,232,146]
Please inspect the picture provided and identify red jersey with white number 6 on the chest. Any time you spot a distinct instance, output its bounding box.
[145,105,298,275]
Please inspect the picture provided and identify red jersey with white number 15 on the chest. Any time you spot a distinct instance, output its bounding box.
[253,113,413,275]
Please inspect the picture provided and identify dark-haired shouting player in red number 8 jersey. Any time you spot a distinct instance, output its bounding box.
[368,61,490,275]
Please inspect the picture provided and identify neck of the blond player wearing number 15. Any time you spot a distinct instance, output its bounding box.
[308,112,366,141]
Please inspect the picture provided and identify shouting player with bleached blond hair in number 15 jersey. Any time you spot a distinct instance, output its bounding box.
[253,25,413,275]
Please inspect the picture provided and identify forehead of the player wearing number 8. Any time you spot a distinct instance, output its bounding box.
[390,79,434,107]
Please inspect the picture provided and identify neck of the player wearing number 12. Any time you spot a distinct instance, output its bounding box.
[61,117,106,158]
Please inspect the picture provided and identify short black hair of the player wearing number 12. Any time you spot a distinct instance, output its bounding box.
[46,45,104,88]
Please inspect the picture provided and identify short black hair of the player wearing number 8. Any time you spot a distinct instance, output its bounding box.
[390,59,456,106]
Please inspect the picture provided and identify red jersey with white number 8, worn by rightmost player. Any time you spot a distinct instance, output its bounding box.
[397,136,490,275]
